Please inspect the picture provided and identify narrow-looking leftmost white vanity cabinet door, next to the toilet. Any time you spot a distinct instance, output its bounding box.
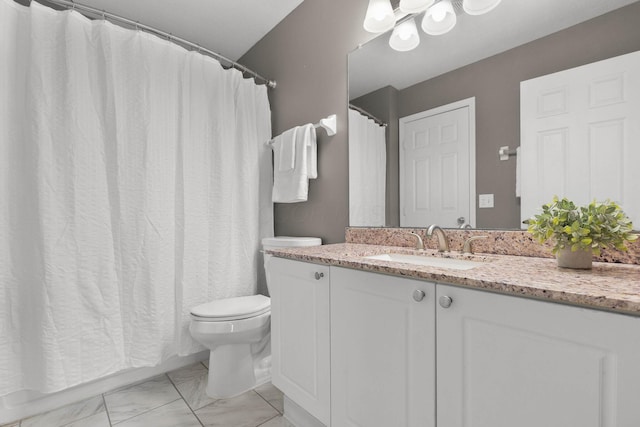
[268,258,331,425]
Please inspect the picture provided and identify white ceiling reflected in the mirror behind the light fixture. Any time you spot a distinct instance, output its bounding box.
[349,0,637,99]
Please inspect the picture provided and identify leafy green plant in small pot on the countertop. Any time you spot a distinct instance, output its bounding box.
[526,196,638,269]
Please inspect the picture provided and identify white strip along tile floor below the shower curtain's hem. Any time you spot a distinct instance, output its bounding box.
[0,351,209,425]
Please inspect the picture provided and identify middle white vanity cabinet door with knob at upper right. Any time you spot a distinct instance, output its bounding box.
[331,267,435,427]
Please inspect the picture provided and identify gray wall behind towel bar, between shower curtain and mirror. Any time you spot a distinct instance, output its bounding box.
[240,0,371,243]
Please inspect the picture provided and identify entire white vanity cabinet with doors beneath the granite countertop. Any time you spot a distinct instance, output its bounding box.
[270,258,640,427]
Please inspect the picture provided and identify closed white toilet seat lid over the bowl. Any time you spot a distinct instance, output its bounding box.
[191,295,271,321]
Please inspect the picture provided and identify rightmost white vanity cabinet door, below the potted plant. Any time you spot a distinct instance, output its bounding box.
[436,285,640,427]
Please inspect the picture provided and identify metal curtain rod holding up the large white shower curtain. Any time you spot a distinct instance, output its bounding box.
[44,0,276,89]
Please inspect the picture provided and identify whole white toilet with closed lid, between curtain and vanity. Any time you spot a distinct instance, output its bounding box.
[189,236,322,399]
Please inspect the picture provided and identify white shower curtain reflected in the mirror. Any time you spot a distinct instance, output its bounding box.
[349,109,387,227]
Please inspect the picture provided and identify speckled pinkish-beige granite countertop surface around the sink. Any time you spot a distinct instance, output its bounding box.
[268,243,640,316]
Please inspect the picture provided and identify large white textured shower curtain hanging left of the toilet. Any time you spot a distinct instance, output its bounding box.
[0,0,273,396]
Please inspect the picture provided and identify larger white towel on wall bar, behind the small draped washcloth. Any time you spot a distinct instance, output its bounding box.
[272,125,318,203]
